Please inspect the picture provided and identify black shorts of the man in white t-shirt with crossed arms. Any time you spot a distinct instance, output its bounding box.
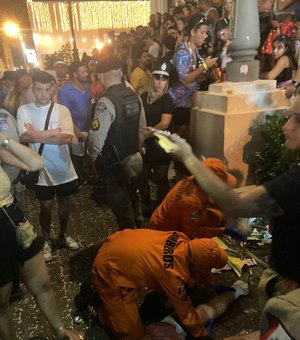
[34,180,79,201]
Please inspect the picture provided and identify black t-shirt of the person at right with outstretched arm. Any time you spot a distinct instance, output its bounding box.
[264,166,300,283]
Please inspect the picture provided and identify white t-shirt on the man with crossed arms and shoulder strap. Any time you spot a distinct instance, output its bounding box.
[17,103,77,186]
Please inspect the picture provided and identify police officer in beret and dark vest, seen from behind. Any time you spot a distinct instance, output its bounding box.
[88,58,146,230]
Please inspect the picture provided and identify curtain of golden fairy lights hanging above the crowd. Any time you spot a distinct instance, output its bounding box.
[27,0,150,33]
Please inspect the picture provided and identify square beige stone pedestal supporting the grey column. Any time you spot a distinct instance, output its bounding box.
[190,80,289,185]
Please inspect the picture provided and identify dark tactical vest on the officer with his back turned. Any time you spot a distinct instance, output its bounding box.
[102,83,141,160]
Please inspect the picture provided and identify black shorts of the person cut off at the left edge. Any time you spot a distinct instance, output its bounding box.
[0,204,41,287]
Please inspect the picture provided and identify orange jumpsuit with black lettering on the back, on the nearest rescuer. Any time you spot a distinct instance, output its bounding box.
[92,229,218,340]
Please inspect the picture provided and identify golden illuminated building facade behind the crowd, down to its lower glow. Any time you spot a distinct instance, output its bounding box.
[27,0,151,55]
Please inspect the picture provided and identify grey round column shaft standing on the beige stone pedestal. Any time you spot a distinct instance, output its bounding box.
[226,0,260,82]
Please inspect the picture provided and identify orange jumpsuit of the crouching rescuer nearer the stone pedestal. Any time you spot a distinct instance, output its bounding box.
[149,176,224,239]
